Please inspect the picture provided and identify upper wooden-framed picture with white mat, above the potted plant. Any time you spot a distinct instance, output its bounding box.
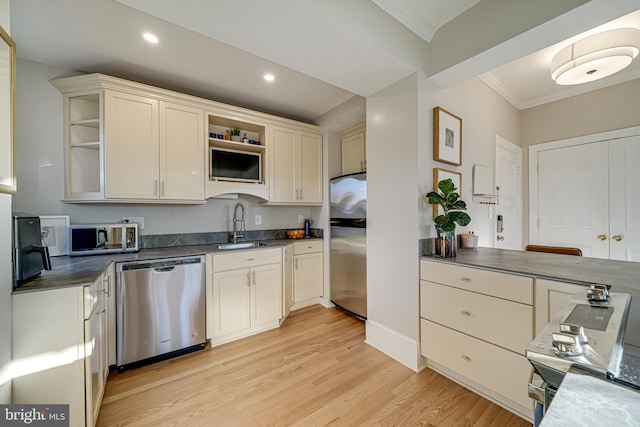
[433,107,462,166]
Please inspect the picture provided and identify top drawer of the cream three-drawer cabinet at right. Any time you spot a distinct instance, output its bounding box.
[420,260,533,305]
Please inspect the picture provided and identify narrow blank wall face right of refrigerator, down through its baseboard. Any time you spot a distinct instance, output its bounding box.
[366,74,419,370]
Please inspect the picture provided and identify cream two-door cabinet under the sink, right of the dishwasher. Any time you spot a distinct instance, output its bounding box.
[207,248,282,345]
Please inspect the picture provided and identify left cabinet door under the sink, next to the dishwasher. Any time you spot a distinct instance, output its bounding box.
[213,268,251,337]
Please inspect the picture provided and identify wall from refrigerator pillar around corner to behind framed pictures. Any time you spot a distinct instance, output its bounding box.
[367,75,519,370]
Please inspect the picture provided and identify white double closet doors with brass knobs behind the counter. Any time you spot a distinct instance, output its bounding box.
[532,136,640,261]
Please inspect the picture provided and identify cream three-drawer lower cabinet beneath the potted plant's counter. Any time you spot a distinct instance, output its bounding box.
[420,260,534,418]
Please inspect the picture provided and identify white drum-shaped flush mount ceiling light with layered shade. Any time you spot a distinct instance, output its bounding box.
[551,28,640,85]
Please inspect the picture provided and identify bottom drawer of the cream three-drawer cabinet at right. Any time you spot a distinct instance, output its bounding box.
[420,319,532,408]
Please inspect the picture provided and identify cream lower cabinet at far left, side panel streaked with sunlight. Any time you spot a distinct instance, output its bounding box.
[12,275,109,427]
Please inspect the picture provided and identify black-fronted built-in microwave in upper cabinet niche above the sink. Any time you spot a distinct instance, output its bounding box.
[209,147,262,183]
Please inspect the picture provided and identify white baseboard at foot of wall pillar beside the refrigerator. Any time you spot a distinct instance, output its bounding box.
[365,319,420,372]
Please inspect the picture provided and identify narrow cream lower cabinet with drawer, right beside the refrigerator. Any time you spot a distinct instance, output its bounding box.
[293,240,324,303]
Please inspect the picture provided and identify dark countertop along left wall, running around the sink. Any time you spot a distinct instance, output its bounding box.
[13,238,322,293]
